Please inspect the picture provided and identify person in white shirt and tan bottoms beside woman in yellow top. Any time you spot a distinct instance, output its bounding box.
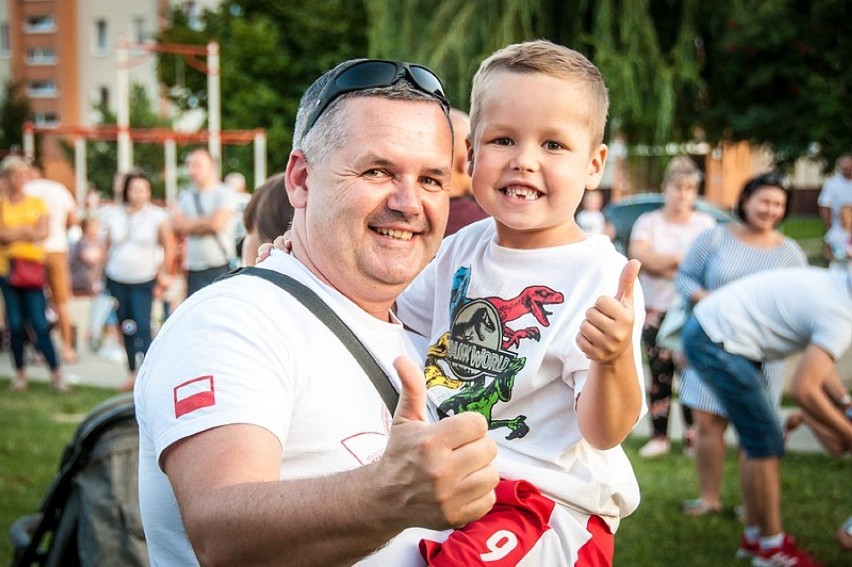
[24,164,77,364]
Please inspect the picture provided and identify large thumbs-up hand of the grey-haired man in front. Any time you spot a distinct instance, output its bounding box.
[377,357,499,529]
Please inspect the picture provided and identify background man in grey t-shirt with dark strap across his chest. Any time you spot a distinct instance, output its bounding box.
[172,149,236,297]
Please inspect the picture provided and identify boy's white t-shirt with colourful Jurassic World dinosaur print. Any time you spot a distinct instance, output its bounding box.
[397,219,645,531]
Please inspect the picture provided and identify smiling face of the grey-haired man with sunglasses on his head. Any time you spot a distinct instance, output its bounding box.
[291,97,453,307]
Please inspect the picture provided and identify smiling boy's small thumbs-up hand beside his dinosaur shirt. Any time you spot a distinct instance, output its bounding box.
[577,259,641,363]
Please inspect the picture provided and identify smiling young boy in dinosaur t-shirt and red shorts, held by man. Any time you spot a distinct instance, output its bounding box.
[397,41,645,565]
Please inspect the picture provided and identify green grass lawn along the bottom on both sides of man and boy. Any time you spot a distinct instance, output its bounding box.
[0,379,852,567]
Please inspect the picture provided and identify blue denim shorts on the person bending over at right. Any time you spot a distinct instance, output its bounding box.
[681,316,784,459]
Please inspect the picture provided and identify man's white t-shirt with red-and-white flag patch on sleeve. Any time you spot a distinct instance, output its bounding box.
[135,251,440,566]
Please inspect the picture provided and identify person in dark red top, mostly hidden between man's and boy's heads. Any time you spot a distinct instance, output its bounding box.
[444,108,488,236]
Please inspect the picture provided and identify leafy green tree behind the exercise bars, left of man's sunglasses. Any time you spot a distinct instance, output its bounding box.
[158,0,366,179]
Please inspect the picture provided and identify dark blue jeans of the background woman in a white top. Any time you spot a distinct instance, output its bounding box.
[106,278,156,372]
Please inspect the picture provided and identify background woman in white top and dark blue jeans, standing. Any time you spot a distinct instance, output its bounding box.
[104,173,175,390]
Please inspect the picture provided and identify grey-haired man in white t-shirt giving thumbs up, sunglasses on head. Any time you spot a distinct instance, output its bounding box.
[135,60,498,565]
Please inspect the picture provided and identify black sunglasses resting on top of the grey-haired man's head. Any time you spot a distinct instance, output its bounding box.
[302,59,450,136]
